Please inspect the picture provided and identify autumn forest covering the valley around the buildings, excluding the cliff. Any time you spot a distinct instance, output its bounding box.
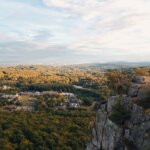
[0,66,150,150]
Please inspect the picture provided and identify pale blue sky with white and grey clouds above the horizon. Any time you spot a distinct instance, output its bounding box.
[0,0,150,64]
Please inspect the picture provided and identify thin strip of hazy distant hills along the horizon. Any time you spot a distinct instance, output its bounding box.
[1,61,150,71]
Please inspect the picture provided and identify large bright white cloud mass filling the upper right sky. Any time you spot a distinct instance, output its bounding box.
[43,0,150,57]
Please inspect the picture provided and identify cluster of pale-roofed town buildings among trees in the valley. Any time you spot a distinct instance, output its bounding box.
[0,91,82,111]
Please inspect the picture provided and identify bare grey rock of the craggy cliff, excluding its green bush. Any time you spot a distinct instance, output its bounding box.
[87,77,150,150]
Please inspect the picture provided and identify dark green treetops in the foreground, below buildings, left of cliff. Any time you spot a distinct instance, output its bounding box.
[0,110,95,150]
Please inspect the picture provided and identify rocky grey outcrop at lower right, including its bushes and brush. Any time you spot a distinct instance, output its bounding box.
[87,76,150,150]
